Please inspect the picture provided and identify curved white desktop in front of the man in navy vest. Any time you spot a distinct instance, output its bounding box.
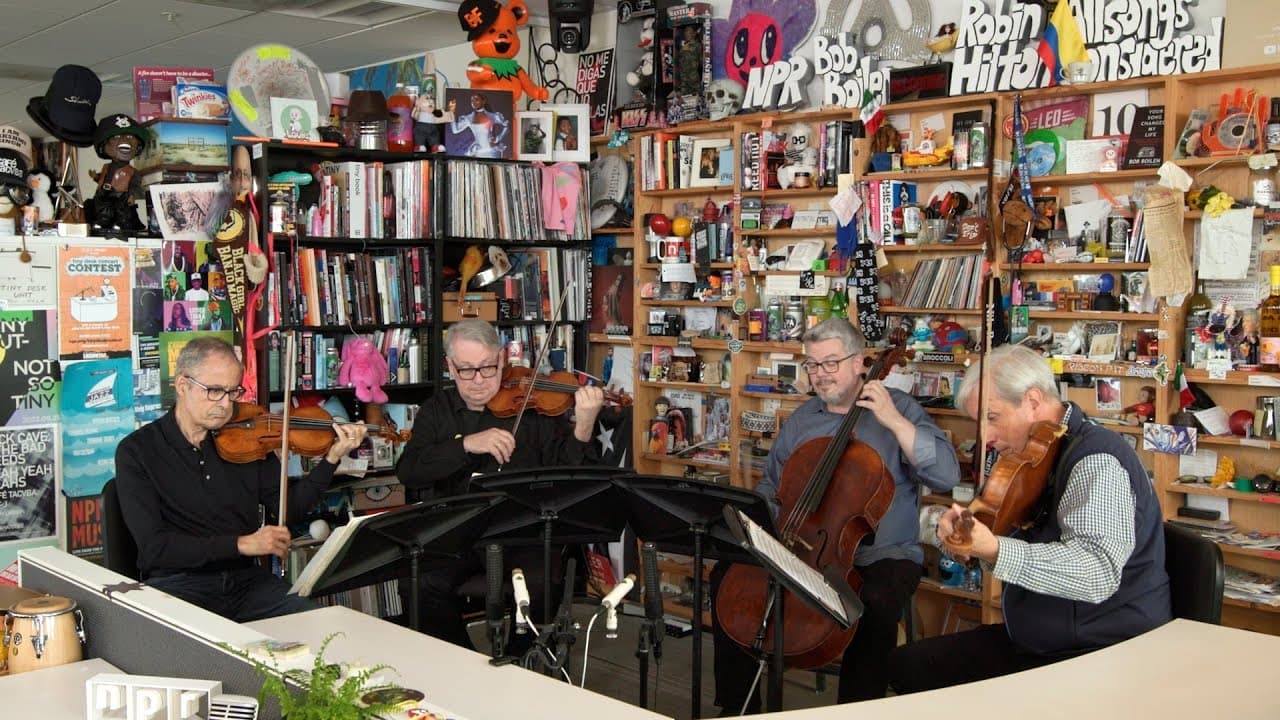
[763,620,1280,720]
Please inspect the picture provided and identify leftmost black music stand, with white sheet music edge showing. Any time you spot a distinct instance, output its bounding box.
[293,492,508,630]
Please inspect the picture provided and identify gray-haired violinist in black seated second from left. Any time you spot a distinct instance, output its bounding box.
[396,319,605,648]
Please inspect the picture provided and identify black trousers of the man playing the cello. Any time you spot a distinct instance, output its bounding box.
[710,550,922,715]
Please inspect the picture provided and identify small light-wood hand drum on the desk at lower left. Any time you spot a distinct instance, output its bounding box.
[4,594,84,675]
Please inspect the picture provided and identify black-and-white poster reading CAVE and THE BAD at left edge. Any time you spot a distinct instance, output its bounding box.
[0,425,59,542]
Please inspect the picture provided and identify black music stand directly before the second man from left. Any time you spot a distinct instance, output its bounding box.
[471,465,627,624]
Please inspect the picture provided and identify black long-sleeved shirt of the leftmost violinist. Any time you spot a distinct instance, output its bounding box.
[115,410,335,578]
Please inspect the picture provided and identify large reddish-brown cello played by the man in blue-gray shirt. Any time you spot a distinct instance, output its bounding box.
[716,333,906,669]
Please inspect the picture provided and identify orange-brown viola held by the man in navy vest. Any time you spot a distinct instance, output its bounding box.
[942,420,1066,555]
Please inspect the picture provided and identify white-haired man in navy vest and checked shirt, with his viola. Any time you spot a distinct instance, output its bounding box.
[888,345,1172,694]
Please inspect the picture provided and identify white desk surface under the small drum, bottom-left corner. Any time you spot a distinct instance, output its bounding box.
[0,659,119,720]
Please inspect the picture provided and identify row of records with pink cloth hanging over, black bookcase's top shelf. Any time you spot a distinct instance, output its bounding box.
[442,159,590,242]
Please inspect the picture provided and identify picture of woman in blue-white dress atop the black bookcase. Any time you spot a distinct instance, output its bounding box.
[444,87,516,160]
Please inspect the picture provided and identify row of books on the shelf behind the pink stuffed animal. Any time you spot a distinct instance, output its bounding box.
[266,328,426,392]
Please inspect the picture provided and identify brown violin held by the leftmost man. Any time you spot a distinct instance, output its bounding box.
[214,402,410,462]
